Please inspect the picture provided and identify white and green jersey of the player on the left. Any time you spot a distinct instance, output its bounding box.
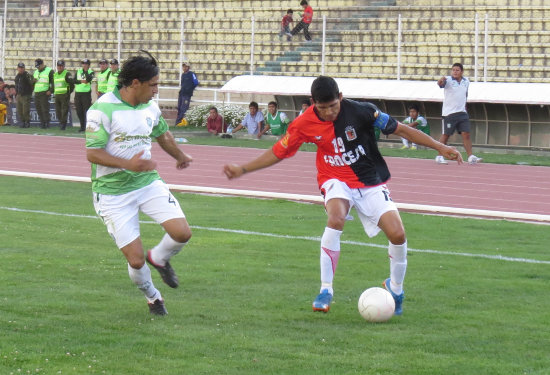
[86,89,168,195]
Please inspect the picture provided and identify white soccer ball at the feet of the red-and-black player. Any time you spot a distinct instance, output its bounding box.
[357,287,395,323]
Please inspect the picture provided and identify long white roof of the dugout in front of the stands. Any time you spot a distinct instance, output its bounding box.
[220,75,550,105]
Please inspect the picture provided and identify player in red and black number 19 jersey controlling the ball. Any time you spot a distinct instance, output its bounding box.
[224,76,462,315]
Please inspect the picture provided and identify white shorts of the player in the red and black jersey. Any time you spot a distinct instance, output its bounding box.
[321,179,397,237]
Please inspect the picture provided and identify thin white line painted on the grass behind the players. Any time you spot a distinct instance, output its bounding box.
[0,206,550,264]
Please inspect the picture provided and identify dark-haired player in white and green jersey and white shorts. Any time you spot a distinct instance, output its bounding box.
[86,55,193,315]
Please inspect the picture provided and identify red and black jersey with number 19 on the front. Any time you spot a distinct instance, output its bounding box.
[272,99,397,188]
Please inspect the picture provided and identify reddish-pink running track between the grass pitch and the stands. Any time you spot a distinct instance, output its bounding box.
[0,133,550,221]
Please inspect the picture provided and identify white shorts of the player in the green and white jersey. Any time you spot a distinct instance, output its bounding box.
[93,180,185,249]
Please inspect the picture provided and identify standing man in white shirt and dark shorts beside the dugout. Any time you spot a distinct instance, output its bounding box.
[435,63,483,164]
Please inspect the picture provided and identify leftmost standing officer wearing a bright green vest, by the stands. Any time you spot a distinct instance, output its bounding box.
[33,59,53,129]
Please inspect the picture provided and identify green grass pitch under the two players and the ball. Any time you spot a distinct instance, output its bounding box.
[0,177,550,375]
